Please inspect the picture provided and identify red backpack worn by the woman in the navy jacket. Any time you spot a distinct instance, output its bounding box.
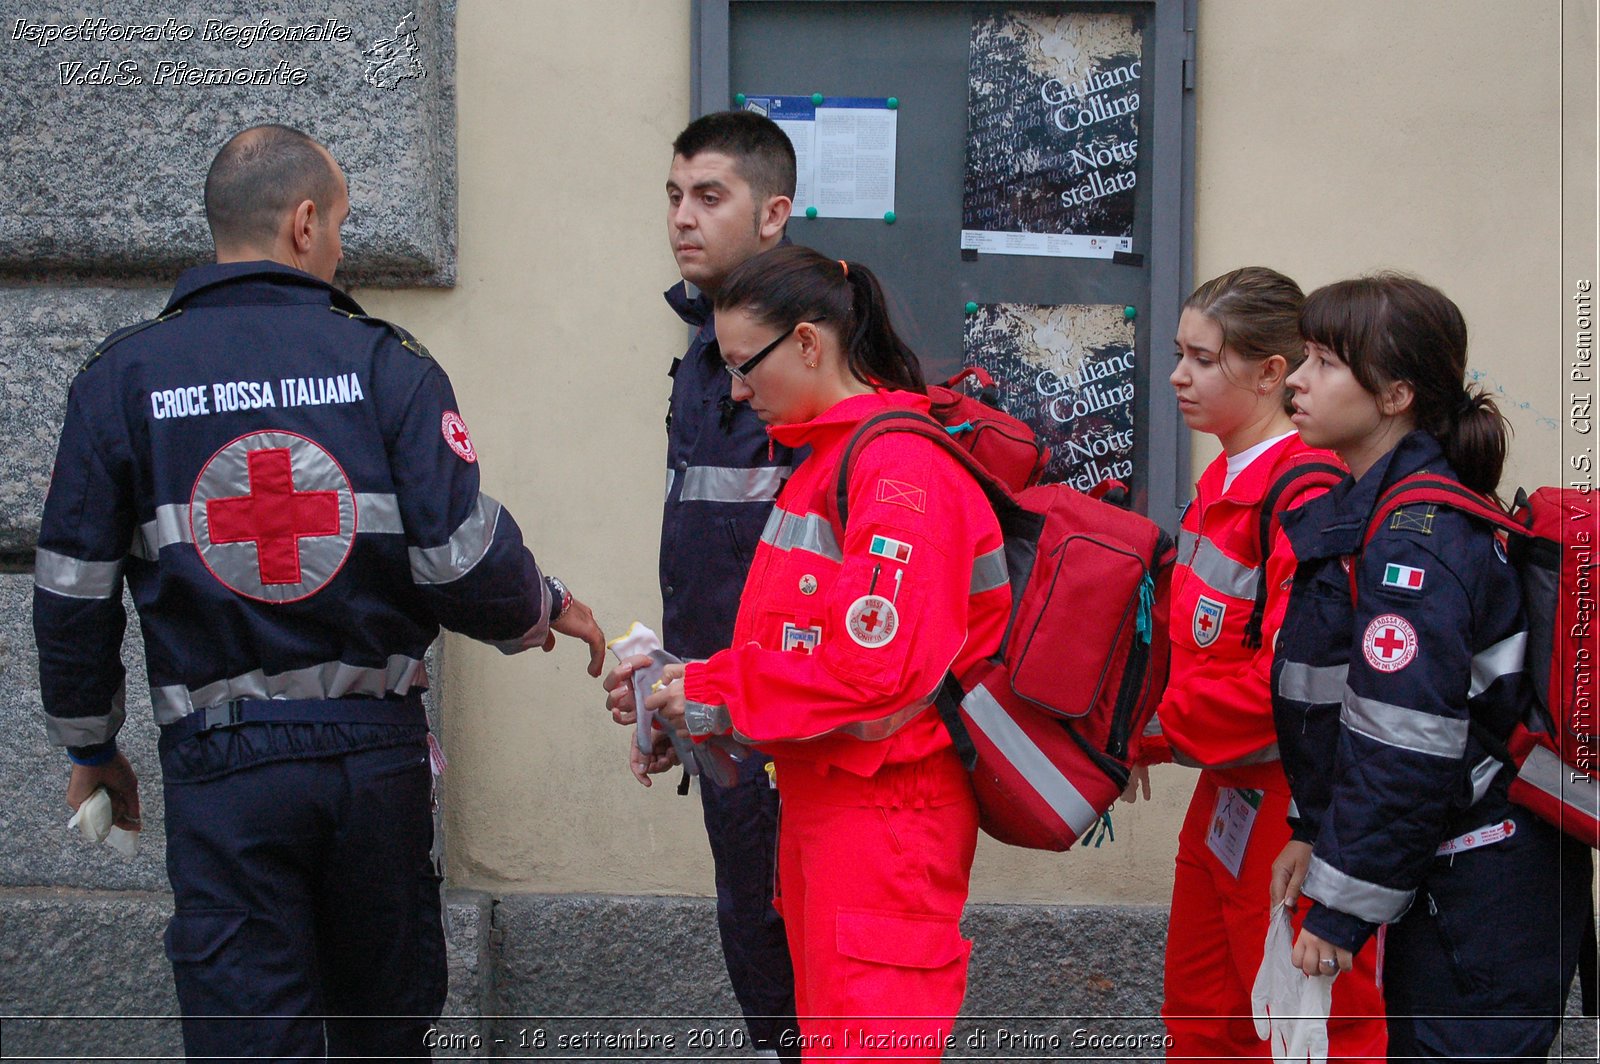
[1363,474,1600,848]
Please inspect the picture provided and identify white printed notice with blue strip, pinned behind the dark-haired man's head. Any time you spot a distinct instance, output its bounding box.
[744,96,899,221]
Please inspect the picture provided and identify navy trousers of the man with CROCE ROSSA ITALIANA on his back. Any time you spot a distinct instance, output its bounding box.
[162,723,446,1059]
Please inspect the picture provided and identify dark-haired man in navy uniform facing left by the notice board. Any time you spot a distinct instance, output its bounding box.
[606,110,798,1059]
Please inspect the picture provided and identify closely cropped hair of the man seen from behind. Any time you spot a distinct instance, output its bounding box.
[205,125,339,245]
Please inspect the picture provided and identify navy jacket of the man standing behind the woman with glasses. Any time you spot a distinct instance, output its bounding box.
[661,282,798,659]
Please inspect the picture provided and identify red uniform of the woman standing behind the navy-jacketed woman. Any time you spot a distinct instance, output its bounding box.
[1146,434,1386,1061]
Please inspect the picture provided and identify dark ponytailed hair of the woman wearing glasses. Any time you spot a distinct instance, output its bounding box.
[714,245,928,394]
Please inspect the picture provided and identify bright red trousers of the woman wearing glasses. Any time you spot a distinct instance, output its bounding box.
[774,750,978,1061]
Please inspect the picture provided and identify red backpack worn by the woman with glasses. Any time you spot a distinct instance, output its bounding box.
[835,389,1178,850]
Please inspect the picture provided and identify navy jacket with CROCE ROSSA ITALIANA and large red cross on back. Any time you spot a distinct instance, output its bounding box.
[34,262,550,757]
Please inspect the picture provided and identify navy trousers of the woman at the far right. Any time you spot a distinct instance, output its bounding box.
[1384,803,1594,1061]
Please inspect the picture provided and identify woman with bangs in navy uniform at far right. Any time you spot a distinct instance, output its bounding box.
[1272,274,1590,1061]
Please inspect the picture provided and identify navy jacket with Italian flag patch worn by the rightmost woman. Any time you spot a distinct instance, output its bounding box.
[1272,432,1533,950]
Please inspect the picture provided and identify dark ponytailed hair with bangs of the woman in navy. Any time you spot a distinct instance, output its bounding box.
[1301,274,1510,496]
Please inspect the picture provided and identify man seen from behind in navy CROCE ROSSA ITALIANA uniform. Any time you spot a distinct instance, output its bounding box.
[34,125,605,1058]
